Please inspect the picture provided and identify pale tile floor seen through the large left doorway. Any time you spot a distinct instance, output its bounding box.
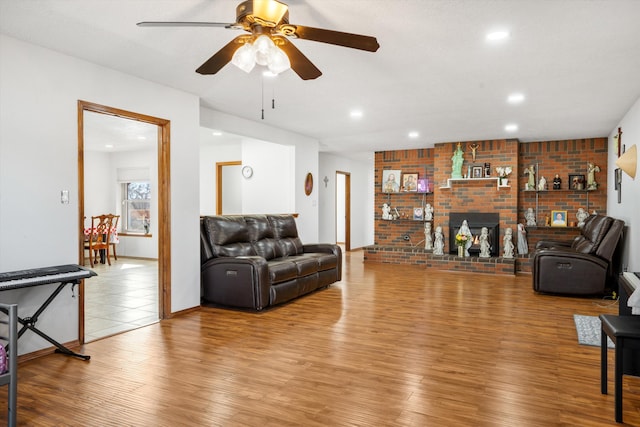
[84,257,159,342]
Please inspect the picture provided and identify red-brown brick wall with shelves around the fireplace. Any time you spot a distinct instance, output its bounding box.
[367,138,608,271]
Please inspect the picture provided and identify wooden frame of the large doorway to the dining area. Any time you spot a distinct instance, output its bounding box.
[77,100,171,342]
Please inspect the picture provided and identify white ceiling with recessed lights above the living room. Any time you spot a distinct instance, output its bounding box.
[0,0,640,158]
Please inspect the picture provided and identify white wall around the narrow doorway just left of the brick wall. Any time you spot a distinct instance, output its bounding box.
[316,153,375,249]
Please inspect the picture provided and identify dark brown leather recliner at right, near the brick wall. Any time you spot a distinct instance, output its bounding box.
[532,215,624,295]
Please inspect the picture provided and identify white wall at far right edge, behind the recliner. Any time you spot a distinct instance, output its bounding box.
[607,98,640,271]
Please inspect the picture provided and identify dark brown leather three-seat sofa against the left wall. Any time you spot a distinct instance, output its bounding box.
[200,215,342,310]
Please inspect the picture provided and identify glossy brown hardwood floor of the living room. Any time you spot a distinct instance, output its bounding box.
[0,252,640,427]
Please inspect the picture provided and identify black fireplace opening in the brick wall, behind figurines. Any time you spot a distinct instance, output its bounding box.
[449,212,500,257]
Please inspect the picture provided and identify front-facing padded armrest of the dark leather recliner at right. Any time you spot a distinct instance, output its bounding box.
[532,249,609,295]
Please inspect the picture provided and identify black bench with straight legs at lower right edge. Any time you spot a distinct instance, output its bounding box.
[599,314,640,423]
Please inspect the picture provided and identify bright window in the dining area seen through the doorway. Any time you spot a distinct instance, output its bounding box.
[122,181,151,234]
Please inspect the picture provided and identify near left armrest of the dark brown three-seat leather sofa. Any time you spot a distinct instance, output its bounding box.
[200,256,271,310]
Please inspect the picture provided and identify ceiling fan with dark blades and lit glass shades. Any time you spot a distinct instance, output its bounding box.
[137,0,380,80]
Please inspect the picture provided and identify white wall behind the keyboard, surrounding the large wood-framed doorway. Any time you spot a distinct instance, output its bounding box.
[0,35,200,353]
